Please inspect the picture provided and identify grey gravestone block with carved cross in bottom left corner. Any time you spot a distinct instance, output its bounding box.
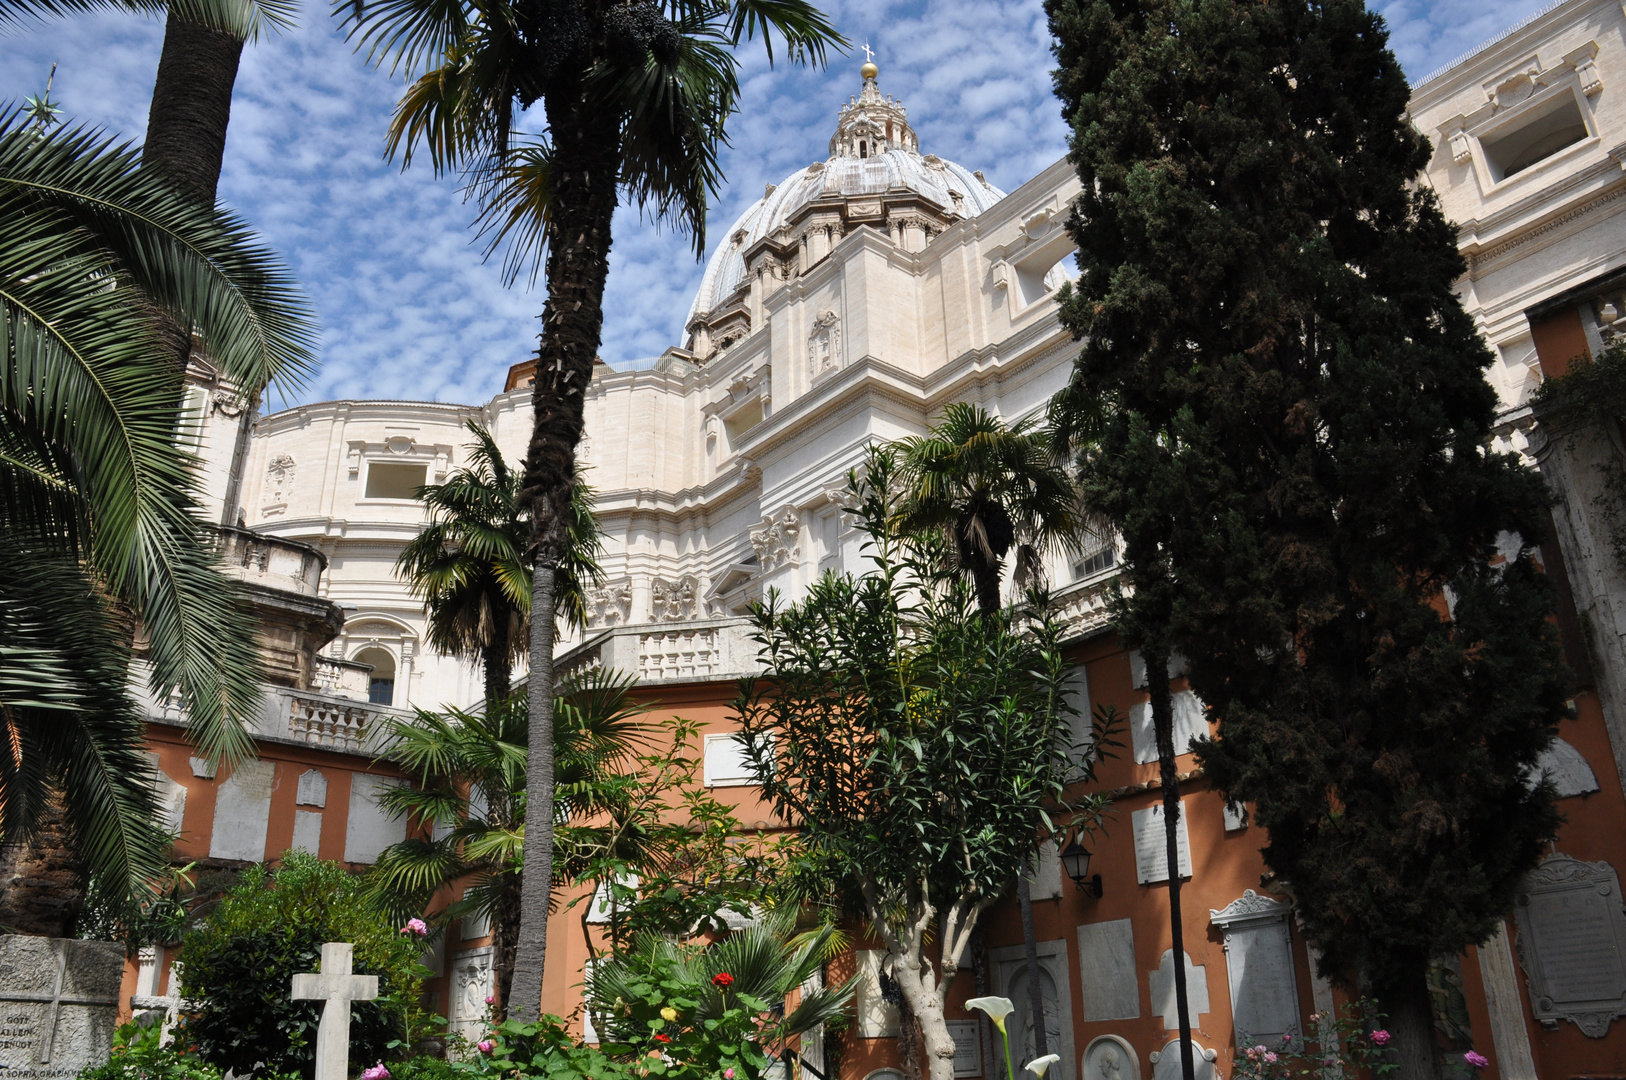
[0,935,124,1080]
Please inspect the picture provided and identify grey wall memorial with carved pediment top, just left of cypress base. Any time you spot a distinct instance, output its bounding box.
[1208,890,1302,1046]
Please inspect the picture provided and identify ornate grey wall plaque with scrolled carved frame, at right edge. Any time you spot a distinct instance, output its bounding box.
[1514,854,1626,1039]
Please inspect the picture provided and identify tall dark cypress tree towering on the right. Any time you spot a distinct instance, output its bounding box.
[1047,0,1567,1077]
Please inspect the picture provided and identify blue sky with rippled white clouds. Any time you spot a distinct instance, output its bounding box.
[0,0,1545,407]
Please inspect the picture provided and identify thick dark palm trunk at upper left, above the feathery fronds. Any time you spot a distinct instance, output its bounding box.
[141,15,242,207]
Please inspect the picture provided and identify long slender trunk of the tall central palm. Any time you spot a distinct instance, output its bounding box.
[509,89,620,1021]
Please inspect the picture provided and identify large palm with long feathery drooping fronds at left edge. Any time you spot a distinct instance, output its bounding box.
[0,111,315,934]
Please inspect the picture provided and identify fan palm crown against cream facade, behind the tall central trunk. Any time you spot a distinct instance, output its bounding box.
[395,420,603,709]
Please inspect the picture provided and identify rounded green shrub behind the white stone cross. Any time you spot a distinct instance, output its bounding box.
[180,851,428,1080]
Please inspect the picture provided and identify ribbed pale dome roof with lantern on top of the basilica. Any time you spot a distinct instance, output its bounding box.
[685,76,1005,325]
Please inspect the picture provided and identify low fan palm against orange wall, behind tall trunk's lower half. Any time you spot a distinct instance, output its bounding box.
[371,668,646,1005]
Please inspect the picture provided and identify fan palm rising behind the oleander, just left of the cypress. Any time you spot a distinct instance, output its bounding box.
[899,402,1080,1057]
